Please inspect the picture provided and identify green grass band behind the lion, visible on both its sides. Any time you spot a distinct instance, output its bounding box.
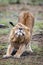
[0,18,43,34]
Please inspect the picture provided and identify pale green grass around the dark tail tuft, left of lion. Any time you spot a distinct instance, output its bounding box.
[0,19,17,34]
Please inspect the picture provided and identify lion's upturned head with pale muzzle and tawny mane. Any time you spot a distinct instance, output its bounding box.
[10,23,30,43]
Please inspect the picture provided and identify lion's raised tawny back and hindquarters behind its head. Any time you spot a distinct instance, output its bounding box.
[18,11,34,33]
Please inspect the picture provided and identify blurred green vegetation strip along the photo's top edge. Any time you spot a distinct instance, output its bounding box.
[0,0,43,5]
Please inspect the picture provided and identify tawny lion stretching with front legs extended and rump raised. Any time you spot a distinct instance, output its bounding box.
[3,11,34,58]
